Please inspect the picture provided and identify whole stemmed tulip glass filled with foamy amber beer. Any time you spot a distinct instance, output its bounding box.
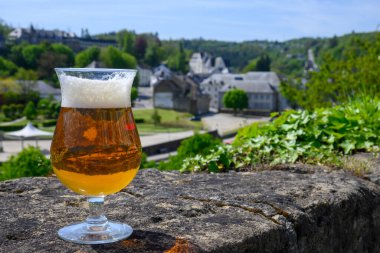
[50,68,141,244]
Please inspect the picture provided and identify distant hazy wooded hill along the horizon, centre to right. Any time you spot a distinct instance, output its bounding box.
[161,33,375,76]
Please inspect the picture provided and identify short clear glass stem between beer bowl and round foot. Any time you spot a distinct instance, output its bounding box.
[86,197,108,232]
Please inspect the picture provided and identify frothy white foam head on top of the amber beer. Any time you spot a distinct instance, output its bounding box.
[59,75,133,108]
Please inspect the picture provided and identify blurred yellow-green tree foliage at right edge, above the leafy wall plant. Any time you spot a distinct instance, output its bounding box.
[281,35,380,109]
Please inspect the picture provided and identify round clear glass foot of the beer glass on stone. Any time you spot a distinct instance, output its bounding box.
[58,221,133,244]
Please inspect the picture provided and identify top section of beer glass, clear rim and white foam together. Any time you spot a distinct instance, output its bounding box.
[56,69,136,108]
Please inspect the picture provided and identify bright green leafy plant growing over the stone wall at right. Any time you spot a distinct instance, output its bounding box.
[181,96,380,171]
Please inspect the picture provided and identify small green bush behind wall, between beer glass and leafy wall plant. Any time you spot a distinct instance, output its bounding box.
[158,133,221,170]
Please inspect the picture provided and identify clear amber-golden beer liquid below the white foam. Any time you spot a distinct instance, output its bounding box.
[51,107,141,196]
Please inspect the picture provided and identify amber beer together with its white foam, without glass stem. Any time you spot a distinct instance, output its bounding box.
[51,70,141,196]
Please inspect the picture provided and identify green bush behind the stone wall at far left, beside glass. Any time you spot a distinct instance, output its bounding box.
[0,147,51,180]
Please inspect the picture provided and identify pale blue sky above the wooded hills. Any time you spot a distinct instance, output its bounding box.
[0,0,380,41]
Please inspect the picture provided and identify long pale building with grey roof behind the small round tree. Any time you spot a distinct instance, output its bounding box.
[200,72,288,114]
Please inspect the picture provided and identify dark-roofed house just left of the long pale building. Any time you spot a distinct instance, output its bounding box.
[153,75,210,114]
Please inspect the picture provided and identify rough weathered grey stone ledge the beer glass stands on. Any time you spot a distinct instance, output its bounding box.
[0,167,380,253]
